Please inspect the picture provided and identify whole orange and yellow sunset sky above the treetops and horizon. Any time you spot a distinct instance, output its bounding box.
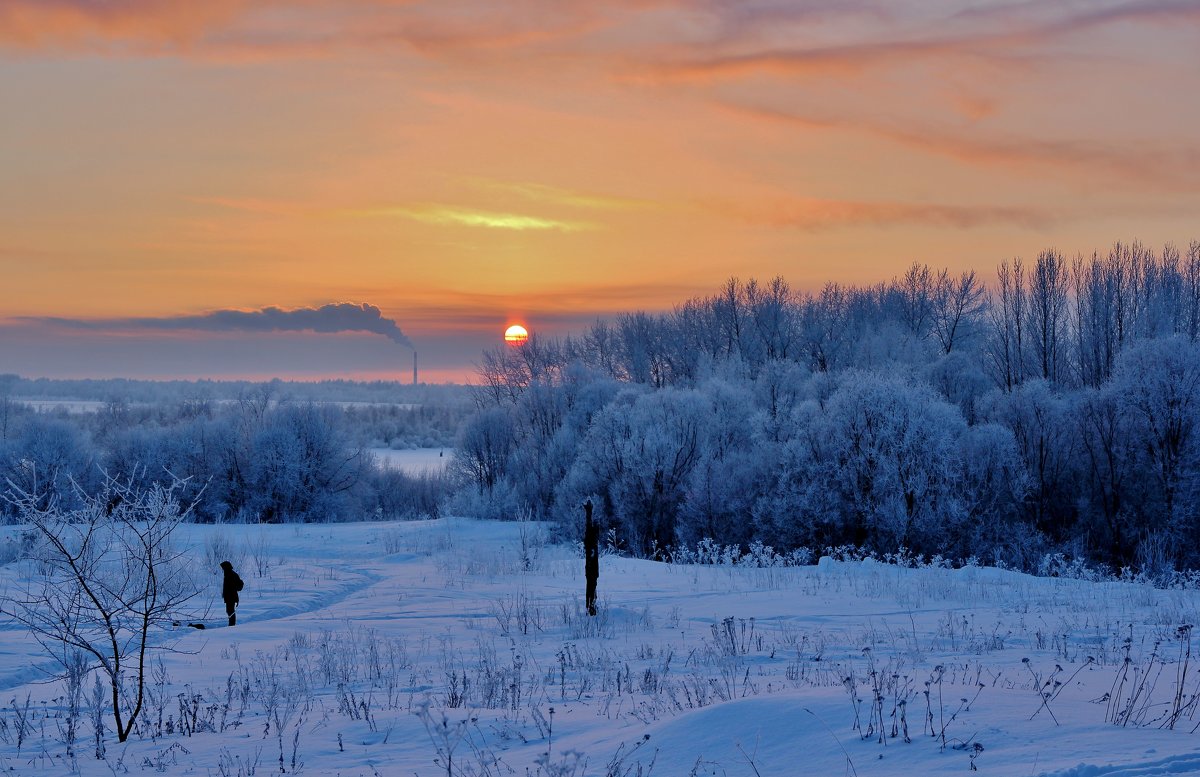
[0,0,1200,383]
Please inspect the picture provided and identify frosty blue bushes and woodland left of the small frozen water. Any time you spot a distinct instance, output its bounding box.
[0,381,468,523]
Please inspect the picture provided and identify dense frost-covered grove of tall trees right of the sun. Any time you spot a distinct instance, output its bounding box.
[455,242,1200,573]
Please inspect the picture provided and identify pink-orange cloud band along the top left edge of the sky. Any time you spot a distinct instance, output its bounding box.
[0,0,619,60]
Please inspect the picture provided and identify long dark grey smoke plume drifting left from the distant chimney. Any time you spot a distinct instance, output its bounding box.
[16,302,413,347]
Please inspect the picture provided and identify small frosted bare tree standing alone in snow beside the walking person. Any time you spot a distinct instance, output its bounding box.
[0,474,198,742]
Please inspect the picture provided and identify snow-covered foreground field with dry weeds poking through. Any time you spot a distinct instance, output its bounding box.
[0,519,1200,777]
